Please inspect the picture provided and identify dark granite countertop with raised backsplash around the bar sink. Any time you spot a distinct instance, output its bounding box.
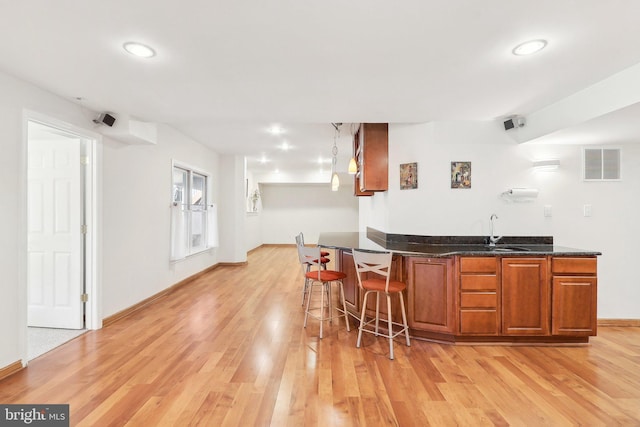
[318,228,602,257]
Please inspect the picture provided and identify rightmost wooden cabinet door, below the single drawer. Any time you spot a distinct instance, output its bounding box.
[551,276,597,336]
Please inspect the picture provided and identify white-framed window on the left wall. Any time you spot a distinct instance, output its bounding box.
[171,164,217,260]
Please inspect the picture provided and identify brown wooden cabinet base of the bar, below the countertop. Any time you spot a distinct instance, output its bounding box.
[336,249,597,343]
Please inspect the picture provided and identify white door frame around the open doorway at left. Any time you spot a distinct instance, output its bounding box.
[18,109,102,366]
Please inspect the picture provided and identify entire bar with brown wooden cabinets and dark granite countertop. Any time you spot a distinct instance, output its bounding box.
[318,228,601,344]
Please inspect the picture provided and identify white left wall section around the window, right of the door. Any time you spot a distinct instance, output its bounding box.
[102,125,220,317]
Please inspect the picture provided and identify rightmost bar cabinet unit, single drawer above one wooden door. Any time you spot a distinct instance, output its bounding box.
[551,257,598,336]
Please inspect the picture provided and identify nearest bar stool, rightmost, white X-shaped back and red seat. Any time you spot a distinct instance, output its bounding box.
[352,249,411,360]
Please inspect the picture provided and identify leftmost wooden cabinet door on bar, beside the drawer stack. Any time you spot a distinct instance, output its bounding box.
[406,257,457,333]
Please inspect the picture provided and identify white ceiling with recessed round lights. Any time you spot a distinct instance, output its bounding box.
[0,0,640,174]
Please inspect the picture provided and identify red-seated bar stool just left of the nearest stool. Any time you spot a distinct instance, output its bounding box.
[298,245,351,339]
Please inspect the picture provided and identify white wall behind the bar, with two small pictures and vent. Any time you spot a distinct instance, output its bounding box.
[360,122,640,319]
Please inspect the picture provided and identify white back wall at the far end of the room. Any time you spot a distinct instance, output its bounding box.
[260,183,358,244]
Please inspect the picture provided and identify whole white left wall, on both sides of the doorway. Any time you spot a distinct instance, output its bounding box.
[0,73,225,368]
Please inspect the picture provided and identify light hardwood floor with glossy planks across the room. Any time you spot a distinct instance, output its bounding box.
[0,247,640,426]
